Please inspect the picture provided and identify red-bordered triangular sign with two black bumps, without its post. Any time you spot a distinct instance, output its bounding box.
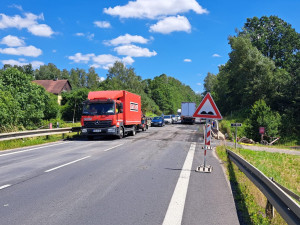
[193,93,223,120]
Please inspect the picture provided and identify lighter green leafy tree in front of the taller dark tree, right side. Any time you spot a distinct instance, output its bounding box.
[215,36,278,113]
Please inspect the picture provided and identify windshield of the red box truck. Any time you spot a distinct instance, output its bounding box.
[82,102,115,115]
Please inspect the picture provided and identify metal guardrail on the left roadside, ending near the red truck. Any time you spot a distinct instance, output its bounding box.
[0,127,81,141]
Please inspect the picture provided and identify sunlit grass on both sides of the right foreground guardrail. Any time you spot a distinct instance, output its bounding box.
[217,146,300,225]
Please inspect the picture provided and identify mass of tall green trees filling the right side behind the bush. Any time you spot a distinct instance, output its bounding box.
[204,16,300,143]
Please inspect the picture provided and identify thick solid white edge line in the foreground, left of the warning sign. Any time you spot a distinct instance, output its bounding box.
[163,142,196,225]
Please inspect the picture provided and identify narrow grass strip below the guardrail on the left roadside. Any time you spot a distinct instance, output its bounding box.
[0,132,77,151]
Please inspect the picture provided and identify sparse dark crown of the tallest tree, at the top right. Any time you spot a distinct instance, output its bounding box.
[239,16,300,72]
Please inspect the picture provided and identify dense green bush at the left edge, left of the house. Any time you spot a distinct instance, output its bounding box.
[0,68,47,132]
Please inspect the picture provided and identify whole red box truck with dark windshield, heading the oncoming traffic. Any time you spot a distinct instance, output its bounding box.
[81,90,147,139]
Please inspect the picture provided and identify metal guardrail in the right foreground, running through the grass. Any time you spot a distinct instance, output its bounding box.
[226,149,300,225]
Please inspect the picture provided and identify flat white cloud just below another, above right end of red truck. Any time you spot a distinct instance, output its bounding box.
[114,45,157,57]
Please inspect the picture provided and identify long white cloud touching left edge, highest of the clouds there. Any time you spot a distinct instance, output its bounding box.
[0,13,54,37]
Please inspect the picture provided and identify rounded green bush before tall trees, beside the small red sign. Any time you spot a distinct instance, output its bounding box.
[246,100,280,141]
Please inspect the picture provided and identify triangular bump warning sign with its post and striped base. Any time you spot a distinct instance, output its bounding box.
[193,93,222,173]
